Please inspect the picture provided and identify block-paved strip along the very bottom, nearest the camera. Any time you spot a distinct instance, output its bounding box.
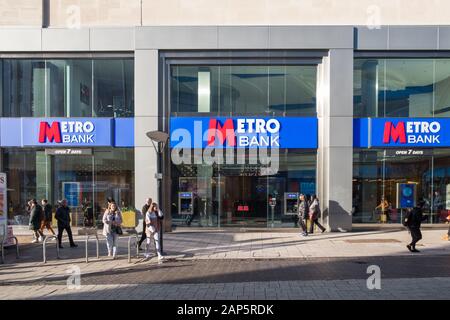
[0,278,450,300]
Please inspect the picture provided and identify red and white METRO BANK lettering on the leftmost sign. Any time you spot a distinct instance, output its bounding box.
[38,121,95,144]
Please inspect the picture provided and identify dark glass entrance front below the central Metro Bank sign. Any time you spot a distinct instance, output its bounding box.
[171,149,317,227]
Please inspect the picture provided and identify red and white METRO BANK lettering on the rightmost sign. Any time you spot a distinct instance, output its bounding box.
[383,121,441,144]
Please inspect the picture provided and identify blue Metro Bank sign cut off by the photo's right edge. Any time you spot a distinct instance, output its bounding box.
[369,118,450,147]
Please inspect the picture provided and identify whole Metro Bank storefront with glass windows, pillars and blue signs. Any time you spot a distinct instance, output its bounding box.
[0,26,450,231]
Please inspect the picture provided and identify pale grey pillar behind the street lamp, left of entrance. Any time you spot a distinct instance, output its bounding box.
[134,50,172,231]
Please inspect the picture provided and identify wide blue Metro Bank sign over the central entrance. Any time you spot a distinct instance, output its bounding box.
[170,117,317,149]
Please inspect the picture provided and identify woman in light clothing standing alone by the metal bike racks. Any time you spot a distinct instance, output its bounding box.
[103,202,122,259]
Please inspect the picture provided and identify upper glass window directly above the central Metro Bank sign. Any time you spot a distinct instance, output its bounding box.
[170,65,316,116]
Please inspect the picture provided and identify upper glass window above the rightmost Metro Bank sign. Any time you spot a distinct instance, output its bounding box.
[354,58,450,117]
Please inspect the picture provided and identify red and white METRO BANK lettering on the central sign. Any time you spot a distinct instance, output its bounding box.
[207,118,281,147]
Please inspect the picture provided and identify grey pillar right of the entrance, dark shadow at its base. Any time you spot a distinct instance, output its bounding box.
[317,49,353,231]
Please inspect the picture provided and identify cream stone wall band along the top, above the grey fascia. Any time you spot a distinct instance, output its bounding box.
[0,0,450,28]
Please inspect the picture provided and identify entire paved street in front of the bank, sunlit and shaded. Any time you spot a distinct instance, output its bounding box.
[0,229,450,299]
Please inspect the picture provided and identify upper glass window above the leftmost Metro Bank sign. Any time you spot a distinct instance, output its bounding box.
[0,59,134,117]
